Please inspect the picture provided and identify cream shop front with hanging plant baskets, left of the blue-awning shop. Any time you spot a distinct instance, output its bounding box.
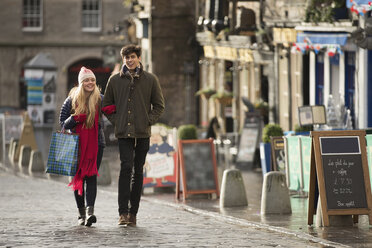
[198,41,267,137]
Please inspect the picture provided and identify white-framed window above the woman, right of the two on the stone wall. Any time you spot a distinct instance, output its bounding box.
[82,0,102,32]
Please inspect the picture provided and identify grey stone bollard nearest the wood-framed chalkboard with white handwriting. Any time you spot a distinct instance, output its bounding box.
[261,171,292,214]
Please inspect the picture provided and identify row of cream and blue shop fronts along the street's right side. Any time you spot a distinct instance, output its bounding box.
[197,0,372,132]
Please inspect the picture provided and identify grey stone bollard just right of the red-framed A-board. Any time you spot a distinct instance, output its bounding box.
[220,169,248,208]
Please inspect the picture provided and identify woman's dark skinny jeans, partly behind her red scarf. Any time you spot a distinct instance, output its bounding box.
[74,146,103,208]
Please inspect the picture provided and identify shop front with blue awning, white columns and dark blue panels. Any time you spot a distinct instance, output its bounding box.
[291,27,360,129]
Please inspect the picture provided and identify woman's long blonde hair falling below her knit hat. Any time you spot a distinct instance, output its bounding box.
[69,84,101,128]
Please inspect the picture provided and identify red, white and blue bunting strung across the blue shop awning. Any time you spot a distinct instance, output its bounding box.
[291,42,343,57]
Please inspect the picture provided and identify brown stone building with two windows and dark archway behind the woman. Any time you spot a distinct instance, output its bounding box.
[0,0,130,125]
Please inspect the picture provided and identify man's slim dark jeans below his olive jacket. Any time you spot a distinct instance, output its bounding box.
[118,138,150,215]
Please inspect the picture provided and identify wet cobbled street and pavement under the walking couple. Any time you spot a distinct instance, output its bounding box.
[0,146,372,247]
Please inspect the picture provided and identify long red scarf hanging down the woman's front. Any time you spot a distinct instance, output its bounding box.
[68,108,99,195]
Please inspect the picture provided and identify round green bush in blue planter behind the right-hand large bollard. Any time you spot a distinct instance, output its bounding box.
[260,123,284,175]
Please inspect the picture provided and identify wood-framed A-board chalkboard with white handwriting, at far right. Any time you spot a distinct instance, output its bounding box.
[308,130,372,226]
